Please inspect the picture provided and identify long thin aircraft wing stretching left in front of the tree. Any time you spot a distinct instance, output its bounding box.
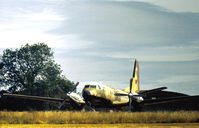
[3,93,69,103]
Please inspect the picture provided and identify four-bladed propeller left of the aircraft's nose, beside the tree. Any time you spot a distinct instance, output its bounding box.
[57,82,81,109]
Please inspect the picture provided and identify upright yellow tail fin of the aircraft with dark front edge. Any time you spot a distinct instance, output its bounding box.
[124,60,140,93]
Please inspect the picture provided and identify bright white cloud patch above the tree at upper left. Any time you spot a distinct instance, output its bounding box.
[0,0,91,51]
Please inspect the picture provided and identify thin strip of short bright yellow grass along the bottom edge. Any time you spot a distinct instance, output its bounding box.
[0,123,199,128]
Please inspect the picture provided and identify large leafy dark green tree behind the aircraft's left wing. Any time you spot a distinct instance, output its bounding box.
[0,43,74,97]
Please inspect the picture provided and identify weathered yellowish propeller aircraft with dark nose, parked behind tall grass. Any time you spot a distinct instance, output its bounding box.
[3,60,199,111]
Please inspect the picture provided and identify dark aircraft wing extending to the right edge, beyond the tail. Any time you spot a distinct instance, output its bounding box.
[142,95,199,106]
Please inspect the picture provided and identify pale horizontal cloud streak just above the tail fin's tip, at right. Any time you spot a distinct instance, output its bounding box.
[106,47,199,62]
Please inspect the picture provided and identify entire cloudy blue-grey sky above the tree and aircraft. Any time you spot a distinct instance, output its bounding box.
[0,0,199,95]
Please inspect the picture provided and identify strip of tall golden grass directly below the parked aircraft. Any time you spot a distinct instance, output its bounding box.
[0,111,199,124]
